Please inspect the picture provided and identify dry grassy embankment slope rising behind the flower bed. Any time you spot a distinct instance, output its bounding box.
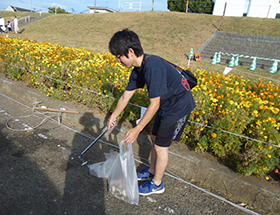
[1,11,280,80]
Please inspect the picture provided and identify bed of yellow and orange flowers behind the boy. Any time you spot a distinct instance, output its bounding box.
[0,36,280,175]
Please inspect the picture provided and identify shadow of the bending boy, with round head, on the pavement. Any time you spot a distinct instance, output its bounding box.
[62,112,107,214]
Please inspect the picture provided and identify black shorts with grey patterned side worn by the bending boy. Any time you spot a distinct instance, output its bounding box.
[152,114,189,147]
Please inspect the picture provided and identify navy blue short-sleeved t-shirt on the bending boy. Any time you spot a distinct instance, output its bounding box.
[126,54,196,121]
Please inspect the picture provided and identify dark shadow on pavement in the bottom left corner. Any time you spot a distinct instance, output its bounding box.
[0,124,63,215]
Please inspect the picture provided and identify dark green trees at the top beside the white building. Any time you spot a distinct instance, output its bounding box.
[168,0,214,14]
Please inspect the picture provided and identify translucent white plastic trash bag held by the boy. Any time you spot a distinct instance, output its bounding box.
[88,141,139,205]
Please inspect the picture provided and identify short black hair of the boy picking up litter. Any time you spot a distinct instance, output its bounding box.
[109,28,144,57]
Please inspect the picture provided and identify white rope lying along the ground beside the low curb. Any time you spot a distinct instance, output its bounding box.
[0,93,260,215]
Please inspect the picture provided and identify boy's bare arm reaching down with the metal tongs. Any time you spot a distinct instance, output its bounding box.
[107,90,135,129]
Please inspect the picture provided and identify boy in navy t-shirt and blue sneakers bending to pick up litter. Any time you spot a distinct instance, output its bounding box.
[108,29,196,195]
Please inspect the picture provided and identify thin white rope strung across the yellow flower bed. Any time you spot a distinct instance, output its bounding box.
[0,60,280,148]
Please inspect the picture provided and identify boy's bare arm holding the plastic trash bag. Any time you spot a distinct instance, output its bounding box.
[124,96,160,143]
